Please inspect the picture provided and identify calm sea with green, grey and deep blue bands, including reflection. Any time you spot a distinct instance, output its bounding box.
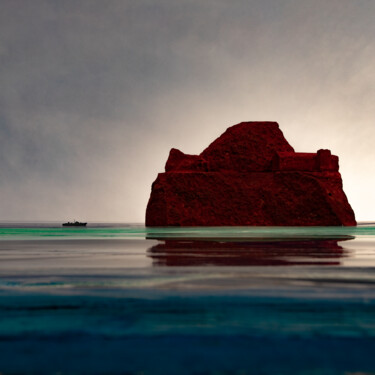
[0,222,375,375]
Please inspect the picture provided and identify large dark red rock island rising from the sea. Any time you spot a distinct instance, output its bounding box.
[146,122,356,226]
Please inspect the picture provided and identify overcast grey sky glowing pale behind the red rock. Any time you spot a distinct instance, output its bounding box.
[0,0,375,222]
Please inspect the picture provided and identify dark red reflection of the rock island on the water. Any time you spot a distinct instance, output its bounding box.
[148,236,353,266]
